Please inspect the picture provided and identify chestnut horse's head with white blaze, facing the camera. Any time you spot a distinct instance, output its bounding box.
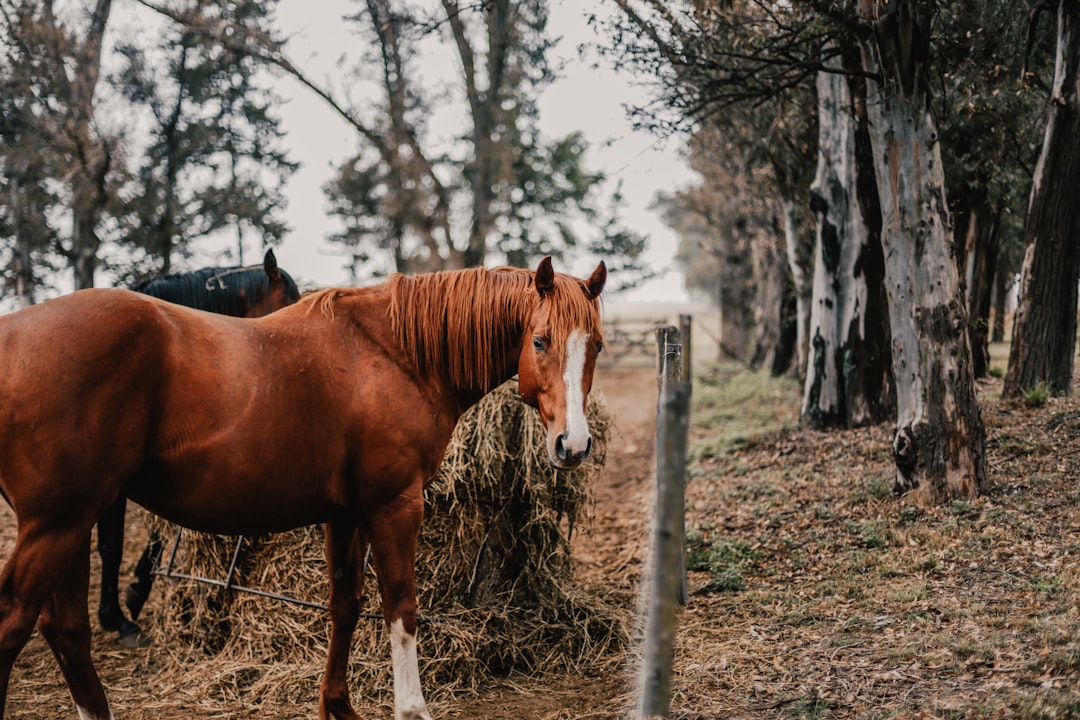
[517,258,607,470]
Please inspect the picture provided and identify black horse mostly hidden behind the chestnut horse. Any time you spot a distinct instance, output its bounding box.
[97,249,300,646]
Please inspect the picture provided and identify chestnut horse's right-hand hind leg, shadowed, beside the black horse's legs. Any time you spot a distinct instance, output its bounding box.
[38,538,112,720]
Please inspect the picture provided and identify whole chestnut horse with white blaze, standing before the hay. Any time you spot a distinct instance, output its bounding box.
[0,258,607,720]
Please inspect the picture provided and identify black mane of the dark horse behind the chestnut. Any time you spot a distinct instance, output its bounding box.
[132,264,299,315]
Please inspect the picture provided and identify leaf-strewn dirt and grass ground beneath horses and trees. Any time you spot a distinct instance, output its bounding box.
[0,351,1080,720]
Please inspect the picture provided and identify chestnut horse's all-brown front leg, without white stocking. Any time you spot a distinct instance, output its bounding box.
[319,521,366,720]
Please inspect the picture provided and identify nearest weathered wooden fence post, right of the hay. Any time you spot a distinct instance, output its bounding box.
[639,327,690,718]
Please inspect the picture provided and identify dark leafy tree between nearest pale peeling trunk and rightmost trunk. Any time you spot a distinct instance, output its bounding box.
[934,0,1053,378]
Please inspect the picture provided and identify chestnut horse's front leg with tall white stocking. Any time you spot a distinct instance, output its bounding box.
[370,491,431,720]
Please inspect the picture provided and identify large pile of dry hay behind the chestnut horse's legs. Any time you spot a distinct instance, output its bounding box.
[145,382,629,704]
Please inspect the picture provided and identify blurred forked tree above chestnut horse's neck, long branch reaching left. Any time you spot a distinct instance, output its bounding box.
[139,0,646,273]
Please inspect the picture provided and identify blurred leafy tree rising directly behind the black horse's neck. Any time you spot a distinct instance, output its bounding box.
[116,0,296,273]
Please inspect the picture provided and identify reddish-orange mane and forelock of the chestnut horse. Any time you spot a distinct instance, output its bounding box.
[309,268,600,393]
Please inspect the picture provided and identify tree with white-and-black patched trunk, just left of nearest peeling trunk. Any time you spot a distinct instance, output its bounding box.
[615,0,892,405]
